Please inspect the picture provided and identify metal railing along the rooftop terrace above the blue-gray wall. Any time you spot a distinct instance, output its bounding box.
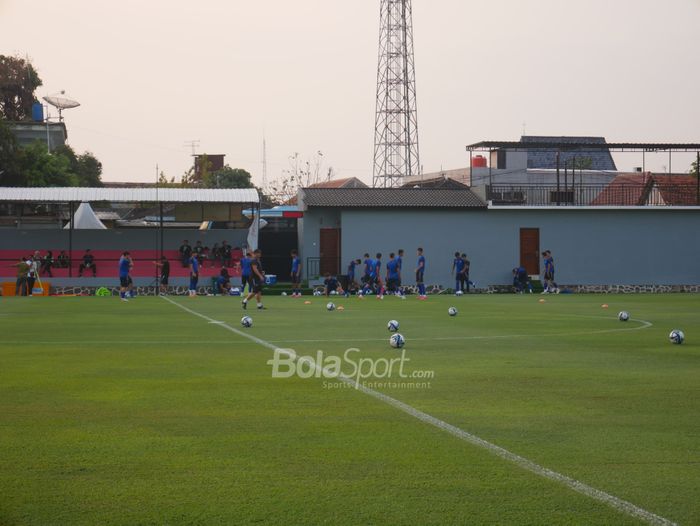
[486,183,700,206]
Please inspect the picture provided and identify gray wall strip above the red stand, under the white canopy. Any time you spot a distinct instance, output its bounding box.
[0,229,248,253]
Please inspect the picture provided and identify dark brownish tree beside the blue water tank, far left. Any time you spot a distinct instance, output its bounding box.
[0,55,42,121]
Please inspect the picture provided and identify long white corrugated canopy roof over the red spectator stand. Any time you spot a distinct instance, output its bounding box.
[0,187,260,204]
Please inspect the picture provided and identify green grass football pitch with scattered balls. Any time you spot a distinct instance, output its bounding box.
[0,294,700,525]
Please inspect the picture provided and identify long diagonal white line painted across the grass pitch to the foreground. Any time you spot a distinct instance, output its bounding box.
[162,296,675,526]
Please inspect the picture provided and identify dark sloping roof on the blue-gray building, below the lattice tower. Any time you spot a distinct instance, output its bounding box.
[301,188,486,208]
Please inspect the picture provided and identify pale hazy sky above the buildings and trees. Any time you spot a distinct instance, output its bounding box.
[0,0,700,184]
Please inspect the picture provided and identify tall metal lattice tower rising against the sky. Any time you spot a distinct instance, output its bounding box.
[373,0,420,188]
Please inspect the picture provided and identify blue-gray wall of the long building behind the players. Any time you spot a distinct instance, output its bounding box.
[301,208,700,286]
